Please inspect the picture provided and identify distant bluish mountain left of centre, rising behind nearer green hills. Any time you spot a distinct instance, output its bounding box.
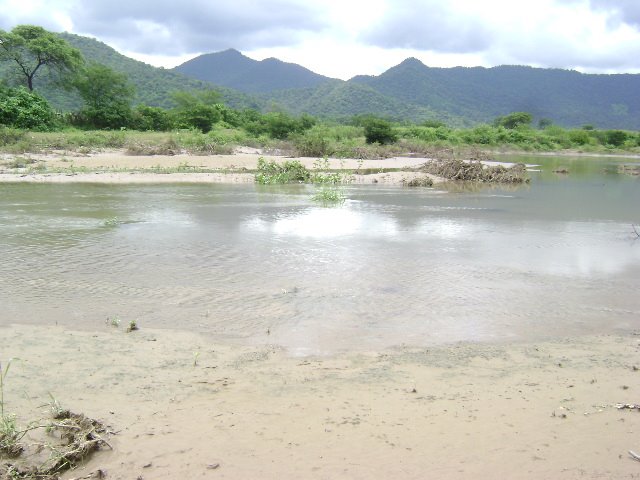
[173,49,335,93]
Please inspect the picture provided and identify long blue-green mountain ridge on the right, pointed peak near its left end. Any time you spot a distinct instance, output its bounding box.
[349,58,640,129]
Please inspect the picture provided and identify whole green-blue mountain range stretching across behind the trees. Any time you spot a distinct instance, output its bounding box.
[0,33,640,130]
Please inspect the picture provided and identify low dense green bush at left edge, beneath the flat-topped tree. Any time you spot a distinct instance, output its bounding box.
[0,85,55,130]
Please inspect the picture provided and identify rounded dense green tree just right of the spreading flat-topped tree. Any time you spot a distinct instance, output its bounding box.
[72,63,135,128]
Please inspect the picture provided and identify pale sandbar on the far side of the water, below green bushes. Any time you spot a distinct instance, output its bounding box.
[0,151,442,185]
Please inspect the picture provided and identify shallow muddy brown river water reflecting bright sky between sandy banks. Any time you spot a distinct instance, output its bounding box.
[0,158,640,354]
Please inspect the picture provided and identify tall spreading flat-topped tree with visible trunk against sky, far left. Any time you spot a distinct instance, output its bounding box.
[0,25,83,91]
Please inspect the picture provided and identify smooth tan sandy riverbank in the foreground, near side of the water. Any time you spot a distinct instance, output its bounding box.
[0,325,640,479]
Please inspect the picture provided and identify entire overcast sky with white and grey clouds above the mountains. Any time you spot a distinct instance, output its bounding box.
[0,0,640,79]
